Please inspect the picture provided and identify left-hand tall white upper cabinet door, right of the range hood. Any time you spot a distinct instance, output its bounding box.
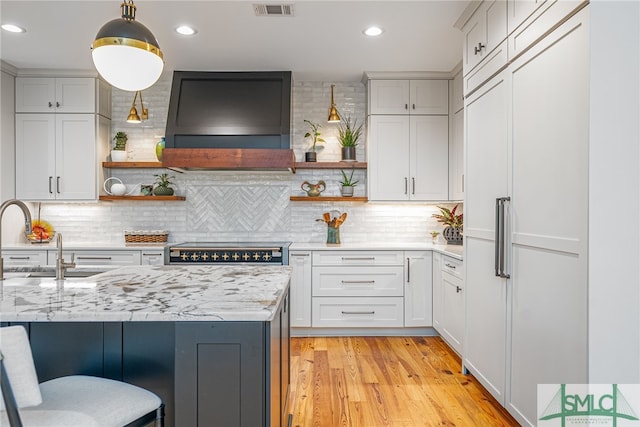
[367,115,410,201]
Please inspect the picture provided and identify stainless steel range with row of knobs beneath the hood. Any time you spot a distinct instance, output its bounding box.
[164,242,291,265]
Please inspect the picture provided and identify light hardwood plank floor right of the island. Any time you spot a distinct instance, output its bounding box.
[289,337,519,427]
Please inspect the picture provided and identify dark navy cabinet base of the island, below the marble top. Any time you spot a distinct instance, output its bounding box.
[0,295,290,427]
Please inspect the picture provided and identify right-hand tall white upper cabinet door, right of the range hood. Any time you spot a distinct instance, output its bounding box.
[409,116,449,201]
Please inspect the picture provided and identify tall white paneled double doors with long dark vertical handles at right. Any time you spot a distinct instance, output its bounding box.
[463,2,589,426]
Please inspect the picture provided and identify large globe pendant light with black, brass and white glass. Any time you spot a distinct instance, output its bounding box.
[91,0,164,91]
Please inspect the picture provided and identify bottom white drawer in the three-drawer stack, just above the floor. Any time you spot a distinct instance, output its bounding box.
[311,297,404,328]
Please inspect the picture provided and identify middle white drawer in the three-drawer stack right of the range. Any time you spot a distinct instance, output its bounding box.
[312,267,404,297]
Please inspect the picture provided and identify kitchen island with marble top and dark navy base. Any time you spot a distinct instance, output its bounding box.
[0,265,291,427]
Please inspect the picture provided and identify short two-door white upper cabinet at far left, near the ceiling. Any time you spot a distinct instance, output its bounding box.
[16,77,96,113]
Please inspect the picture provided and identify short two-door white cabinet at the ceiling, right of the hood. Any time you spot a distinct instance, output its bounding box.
[369,80,449,114]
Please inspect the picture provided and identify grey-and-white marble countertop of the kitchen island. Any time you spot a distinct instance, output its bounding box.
[0,265,291,322]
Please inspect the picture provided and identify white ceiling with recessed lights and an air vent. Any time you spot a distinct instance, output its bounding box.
[0,0,468,81]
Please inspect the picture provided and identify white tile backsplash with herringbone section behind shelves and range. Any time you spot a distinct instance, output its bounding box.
[17,79,458,244]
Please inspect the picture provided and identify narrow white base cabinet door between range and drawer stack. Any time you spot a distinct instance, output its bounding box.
[289,251,311,327]
